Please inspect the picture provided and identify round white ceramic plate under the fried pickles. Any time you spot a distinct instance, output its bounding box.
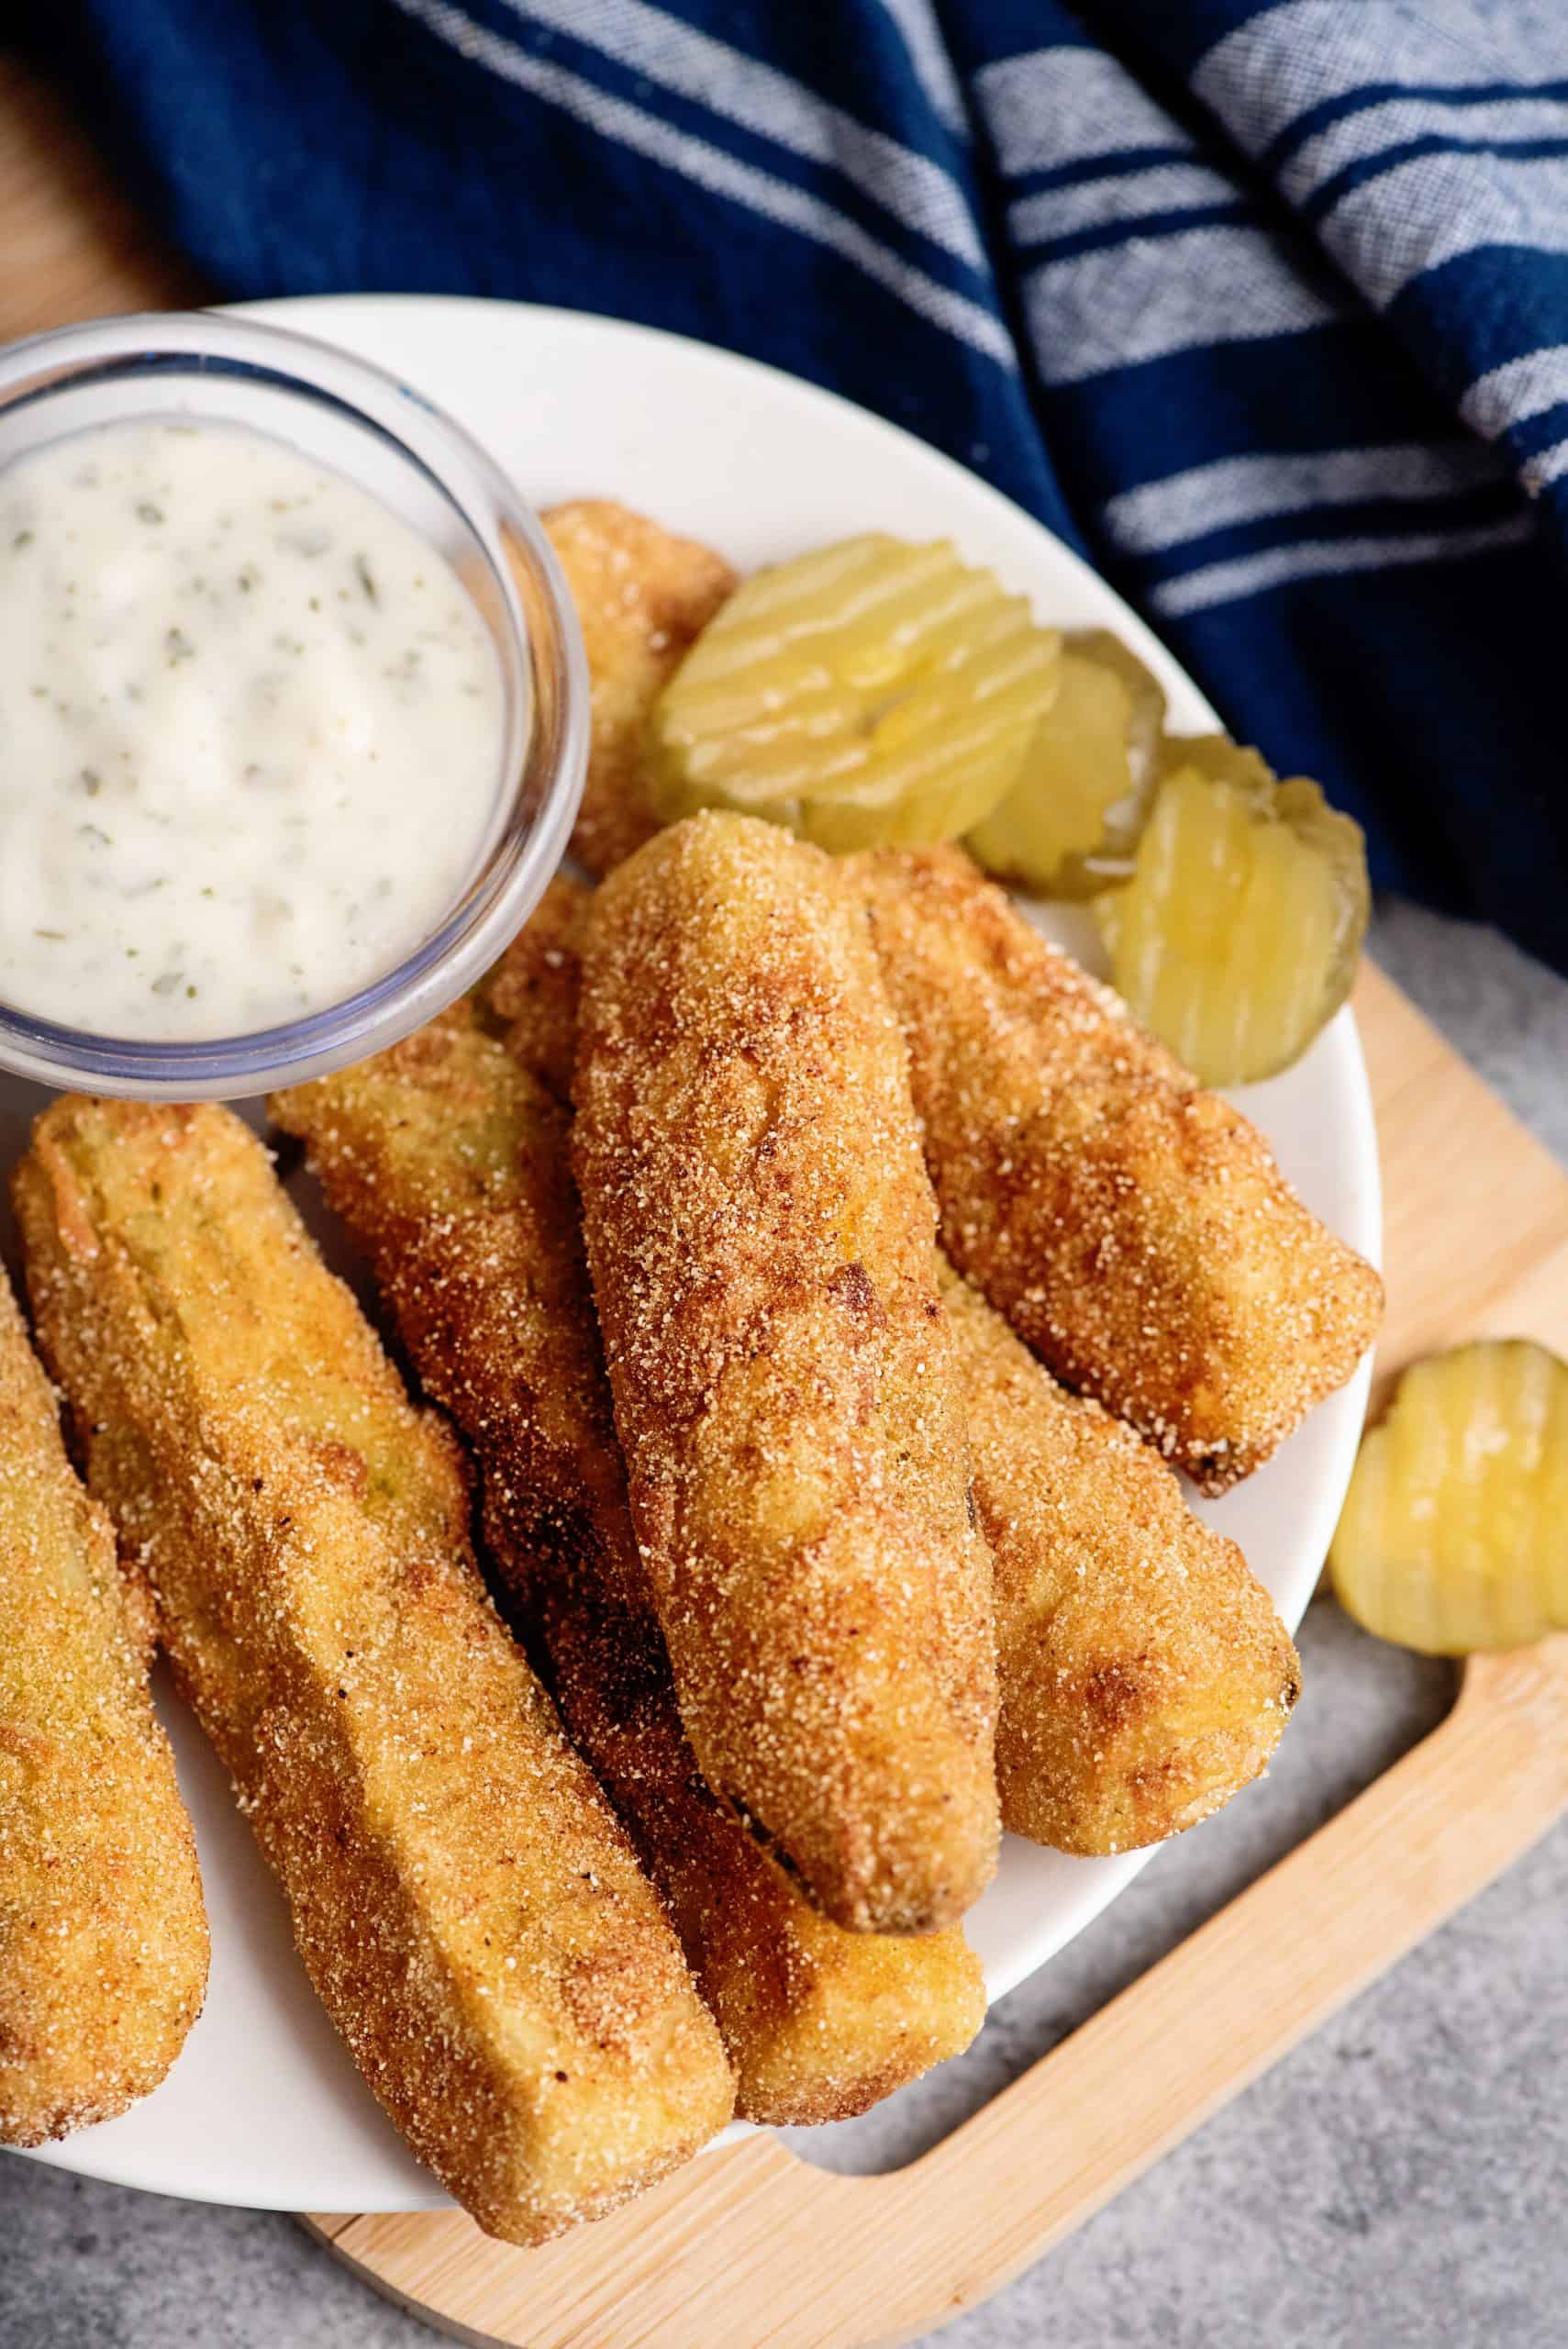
[15,298,1380,2210]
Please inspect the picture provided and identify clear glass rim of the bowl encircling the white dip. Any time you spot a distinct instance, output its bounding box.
[0,310,589,1102]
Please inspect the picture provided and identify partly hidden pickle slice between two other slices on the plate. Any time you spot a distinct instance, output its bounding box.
[967,628,1164,897]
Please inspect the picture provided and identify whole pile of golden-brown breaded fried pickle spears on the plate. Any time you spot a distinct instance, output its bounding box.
[0,503,1380,2243]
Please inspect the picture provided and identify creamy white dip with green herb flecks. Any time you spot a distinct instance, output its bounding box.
[0,423,502,1041]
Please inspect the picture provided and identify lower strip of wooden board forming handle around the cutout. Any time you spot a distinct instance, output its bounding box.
[306,1637,1568,2349]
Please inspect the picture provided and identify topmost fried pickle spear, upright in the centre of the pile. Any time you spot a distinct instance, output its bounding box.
[573,815,997,1933]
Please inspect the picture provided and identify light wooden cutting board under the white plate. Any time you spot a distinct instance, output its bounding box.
[0,59,1568,2349]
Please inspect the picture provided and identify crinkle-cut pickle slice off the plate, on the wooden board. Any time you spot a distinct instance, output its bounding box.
[1329,1339,1568,1656]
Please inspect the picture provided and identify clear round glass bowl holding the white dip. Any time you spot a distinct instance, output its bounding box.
[0,312,589,1102]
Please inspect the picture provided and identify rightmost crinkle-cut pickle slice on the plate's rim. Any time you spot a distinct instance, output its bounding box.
[1094,751,1371,1085]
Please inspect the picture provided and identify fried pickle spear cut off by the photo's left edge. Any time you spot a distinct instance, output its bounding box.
[0,1271,206,2144]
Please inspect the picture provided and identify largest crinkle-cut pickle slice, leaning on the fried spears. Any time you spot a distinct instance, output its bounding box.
[648,533,1061,848]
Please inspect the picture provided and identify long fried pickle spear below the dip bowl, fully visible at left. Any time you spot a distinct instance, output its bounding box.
[17,1099,732,2243]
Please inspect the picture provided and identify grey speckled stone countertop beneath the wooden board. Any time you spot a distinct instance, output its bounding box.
[0,905,1568,2349]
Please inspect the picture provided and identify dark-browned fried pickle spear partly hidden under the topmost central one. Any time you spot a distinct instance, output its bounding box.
[272,1009,986,2123]
